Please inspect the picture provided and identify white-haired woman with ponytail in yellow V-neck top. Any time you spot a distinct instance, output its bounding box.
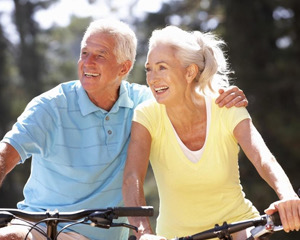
[123,26,300,240]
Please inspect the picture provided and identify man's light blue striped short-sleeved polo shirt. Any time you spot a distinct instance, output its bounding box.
[2,81,152,240]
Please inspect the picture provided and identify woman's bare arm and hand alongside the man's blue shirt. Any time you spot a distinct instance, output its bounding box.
[123,122,153,239]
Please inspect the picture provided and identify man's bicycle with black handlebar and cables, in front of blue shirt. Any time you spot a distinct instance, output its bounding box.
[0,206,154,240]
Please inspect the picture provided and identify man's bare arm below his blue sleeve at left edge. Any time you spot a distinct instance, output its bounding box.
[0,142,20,186]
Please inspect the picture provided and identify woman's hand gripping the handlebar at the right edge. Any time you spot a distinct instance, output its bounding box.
[265,198,300,232]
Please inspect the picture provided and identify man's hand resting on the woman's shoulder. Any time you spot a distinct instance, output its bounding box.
[216,86,248,108]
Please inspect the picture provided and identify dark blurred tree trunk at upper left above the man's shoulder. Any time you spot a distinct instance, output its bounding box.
[14,0,57,98]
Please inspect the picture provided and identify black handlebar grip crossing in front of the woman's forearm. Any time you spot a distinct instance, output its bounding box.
[113,206,154,217]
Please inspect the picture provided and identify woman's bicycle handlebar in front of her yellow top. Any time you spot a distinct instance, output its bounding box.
[171,212,283,240]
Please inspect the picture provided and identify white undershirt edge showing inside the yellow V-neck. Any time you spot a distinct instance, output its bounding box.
[172,97,211,163]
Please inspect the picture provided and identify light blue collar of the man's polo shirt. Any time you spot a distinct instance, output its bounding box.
[76,81,134,116]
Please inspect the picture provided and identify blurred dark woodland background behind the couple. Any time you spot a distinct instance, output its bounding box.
[0,0,300,240]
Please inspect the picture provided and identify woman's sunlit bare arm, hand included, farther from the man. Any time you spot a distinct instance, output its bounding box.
[233,119,300,232]
